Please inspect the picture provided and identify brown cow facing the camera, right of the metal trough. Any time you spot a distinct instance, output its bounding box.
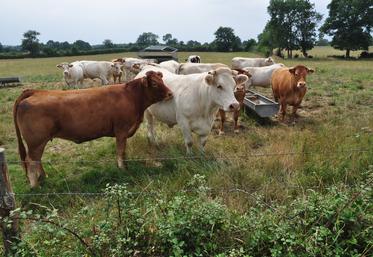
[272,65,314,121]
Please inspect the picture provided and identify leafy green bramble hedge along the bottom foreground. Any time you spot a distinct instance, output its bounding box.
[8,170,373,257]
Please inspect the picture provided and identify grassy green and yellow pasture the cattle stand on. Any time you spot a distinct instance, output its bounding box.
[0,48,373,256]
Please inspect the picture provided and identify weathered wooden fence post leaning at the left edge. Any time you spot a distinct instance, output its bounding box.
[0,148,19,256]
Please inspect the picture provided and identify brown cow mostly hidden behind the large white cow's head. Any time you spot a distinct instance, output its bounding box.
[219,69,251,135]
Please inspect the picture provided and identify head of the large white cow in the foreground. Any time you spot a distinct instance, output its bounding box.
[205,68,248,111]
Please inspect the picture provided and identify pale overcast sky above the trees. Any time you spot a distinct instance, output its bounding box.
[0,0,330,45]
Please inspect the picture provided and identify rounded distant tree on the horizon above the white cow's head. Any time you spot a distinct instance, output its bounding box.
[214,27,241,52]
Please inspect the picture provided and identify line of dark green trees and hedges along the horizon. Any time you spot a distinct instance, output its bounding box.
[0,0,373,58]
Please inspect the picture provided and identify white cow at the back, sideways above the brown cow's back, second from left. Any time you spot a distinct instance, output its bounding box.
[79,61,122,85]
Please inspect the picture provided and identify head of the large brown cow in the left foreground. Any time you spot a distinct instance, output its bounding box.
[142,71,173,103]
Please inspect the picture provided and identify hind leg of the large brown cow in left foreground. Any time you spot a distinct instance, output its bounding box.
[26,141,48,187]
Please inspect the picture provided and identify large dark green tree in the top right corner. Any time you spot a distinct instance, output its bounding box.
[321,0,373,58]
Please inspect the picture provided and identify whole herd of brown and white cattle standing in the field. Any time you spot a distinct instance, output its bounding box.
[13,56,313,187]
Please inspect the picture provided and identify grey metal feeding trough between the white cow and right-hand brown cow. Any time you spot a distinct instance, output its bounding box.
[243,90,279,118]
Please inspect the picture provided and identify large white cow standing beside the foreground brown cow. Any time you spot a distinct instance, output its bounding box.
[137,66,247,154]
